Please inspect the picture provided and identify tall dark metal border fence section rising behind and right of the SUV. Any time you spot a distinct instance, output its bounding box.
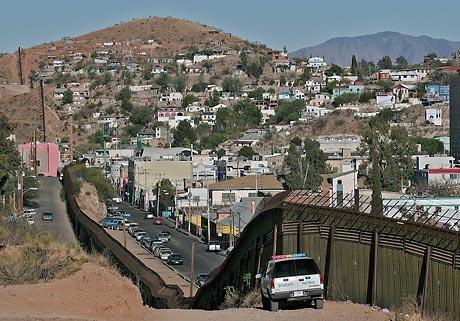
[194,191,460,320]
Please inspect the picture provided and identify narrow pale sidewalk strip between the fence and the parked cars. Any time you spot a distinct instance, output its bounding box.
[106,229,197,298]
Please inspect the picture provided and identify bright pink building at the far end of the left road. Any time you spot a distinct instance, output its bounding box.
[18,143,60,177]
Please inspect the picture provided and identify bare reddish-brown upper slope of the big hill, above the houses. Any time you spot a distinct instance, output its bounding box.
[0,17,248,84]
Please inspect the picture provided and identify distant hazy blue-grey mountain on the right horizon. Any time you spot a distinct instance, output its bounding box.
[291,31,460,66]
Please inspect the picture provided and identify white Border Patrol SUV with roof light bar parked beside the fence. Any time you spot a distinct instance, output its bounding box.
[256,253,324,311]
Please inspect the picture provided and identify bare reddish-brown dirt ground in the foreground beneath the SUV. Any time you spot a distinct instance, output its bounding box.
[0,263,390,321]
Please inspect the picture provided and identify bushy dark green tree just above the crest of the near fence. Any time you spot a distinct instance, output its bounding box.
[284,138,326,190]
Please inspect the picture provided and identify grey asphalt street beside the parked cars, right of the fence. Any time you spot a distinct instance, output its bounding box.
[118,204,225,278]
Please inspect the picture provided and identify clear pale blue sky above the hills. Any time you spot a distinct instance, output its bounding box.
[0,0,460,52]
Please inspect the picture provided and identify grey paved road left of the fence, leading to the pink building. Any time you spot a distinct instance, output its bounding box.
[35,176,77,243]
